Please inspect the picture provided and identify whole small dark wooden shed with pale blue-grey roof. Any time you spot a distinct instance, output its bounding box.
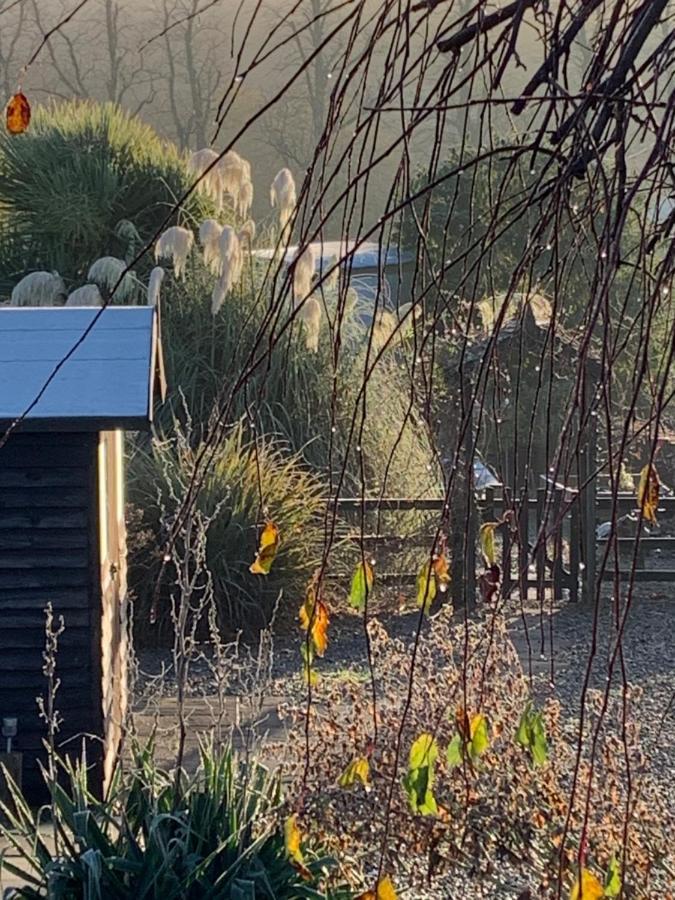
[0,307,164,800]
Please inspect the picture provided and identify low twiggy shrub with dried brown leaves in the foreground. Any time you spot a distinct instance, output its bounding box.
[274,607,673,900]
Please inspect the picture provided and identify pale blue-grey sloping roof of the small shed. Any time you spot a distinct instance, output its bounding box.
[0,306,164,431]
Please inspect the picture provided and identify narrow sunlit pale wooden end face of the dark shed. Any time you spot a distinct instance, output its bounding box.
[99,431,127,790]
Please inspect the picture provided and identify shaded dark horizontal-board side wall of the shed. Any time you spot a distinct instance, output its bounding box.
[0,431,102,799]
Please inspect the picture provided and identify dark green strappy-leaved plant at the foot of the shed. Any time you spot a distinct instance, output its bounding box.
[0,745,347,900]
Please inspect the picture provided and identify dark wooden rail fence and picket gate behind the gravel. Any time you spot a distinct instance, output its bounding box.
[336,488,675,602]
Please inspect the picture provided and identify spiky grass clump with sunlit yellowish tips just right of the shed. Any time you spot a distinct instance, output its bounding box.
[129,423,324,629]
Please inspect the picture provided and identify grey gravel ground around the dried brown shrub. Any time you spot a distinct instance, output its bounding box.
[139,587,675,900]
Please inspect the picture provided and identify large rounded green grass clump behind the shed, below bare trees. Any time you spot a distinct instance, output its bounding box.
[0,101,213,291]
